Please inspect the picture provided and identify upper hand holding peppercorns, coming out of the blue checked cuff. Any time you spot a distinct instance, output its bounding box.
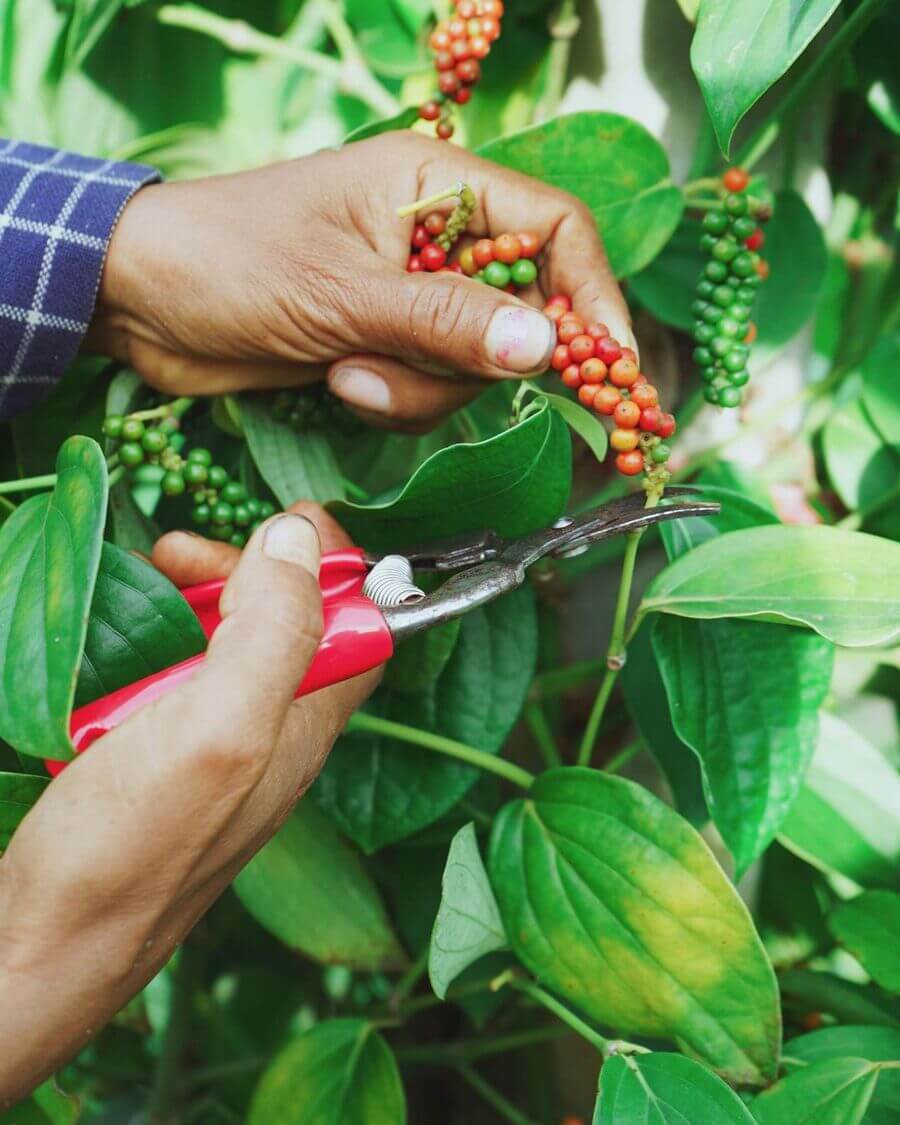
[89,131,633,429]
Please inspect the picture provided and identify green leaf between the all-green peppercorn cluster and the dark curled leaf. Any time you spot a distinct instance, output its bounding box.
[240,395,344,507]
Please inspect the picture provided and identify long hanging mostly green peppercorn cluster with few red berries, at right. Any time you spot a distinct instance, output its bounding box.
[691,168,771,406]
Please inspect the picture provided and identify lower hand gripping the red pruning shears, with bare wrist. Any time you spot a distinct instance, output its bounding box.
[0,506,378,1108]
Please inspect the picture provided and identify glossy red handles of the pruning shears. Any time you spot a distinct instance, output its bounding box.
[45,550,394,777]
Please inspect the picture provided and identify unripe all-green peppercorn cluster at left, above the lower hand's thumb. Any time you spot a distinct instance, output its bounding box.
[104,407,275,547]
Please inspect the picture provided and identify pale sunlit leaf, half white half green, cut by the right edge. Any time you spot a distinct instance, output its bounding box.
[779,711,900,887]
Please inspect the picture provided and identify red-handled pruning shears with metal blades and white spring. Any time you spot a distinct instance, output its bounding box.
[47,488,719,774]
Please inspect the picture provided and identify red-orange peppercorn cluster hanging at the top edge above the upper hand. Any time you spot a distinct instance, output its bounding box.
[419,0,503,141]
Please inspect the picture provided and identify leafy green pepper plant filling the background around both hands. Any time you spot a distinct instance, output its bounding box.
[0,0,900,1125]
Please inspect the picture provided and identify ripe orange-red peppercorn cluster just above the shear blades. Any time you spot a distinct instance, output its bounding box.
[543,296,675,477]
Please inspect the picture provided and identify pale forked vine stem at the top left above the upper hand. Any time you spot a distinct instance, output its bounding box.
[156,3,402,117]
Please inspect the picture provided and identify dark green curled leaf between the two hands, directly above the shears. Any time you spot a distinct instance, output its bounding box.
[331,407,572,551]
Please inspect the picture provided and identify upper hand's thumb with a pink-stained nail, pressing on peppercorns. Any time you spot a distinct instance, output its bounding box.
[363,270,556,379]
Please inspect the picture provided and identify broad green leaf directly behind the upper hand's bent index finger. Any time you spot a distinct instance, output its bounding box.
[478,113,684,277]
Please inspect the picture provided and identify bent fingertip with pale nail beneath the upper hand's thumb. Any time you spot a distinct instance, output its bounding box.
[329,354,485,433]
